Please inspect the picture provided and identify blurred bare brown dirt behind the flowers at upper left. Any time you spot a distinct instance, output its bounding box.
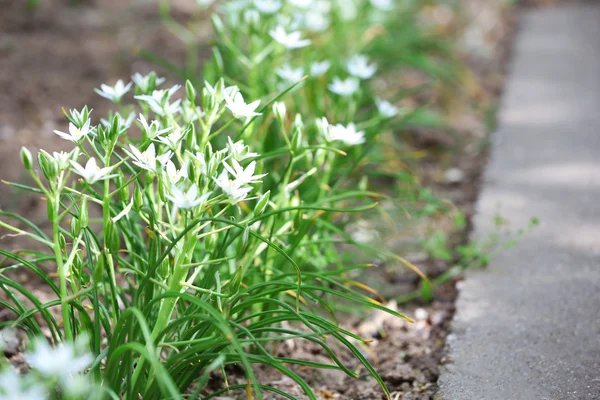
[0,0,196,230]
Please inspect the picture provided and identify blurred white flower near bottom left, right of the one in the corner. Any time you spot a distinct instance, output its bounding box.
[25,338,93,381]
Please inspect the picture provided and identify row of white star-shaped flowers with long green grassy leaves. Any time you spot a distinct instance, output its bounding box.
[0,0,426,398]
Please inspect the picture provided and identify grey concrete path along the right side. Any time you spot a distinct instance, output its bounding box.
[438,2,600,400]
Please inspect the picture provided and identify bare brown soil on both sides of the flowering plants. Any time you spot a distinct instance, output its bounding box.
[0,0,511,400]
